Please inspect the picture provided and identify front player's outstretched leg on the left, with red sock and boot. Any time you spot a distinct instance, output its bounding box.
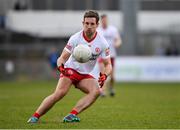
[28,77,72,123]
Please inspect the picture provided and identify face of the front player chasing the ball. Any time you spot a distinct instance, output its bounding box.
[83,17,98,37]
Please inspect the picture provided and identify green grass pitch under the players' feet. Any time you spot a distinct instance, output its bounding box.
[0,81,180,129]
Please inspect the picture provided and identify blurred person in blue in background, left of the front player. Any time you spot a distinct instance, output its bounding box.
[48,47,59,78]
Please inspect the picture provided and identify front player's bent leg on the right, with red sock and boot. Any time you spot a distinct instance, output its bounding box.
[63,79,100,122]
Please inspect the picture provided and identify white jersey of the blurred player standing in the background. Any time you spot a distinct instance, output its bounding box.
[98,25,119,57]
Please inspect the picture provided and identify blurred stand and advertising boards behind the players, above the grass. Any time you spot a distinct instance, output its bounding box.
[0,0,180,82]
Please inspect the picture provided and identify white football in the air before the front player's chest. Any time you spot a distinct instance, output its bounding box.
[73,44,92,63]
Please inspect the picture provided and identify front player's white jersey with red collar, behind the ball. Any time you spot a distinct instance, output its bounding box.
[65,30,110,74]
